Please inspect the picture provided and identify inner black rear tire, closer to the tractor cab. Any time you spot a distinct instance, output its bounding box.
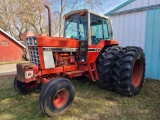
[96,46,121,90]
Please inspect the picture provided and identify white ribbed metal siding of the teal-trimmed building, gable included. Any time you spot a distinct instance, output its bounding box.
[110,0,160,50]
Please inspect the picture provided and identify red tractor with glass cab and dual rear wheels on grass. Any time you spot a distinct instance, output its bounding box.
[14,5,145,117]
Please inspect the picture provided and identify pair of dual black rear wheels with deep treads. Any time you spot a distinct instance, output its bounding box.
[97,46,145,96]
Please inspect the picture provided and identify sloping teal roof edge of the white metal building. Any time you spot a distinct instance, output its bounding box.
[104,0,135,16]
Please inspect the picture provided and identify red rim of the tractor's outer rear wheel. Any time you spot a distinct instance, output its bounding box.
[132,59,143,87]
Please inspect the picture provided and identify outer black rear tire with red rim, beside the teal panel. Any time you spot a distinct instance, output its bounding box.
[113,47,145,96]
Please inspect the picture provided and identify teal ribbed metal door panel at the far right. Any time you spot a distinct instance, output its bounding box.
[145,9,160,80]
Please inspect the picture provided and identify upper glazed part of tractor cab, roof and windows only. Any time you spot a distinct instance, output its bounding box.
[64,9,112,45]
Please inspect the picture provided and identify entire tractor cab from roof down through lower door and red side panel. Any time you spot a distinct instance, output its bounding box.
[63,9,114,63]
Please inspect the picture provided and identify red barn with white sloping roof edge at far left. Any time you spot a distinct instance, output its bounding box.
[0,28,26,62]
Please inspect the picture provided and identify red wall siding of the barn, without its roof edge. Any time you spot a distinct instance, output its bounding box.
[0,32,22,62]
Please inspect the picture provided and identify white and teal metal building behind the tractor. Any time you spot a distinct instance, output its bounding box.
[105,0,160,80]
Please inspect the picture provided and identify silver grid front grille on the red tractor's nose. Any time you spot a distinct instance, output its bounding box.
[28,47,40,67]
